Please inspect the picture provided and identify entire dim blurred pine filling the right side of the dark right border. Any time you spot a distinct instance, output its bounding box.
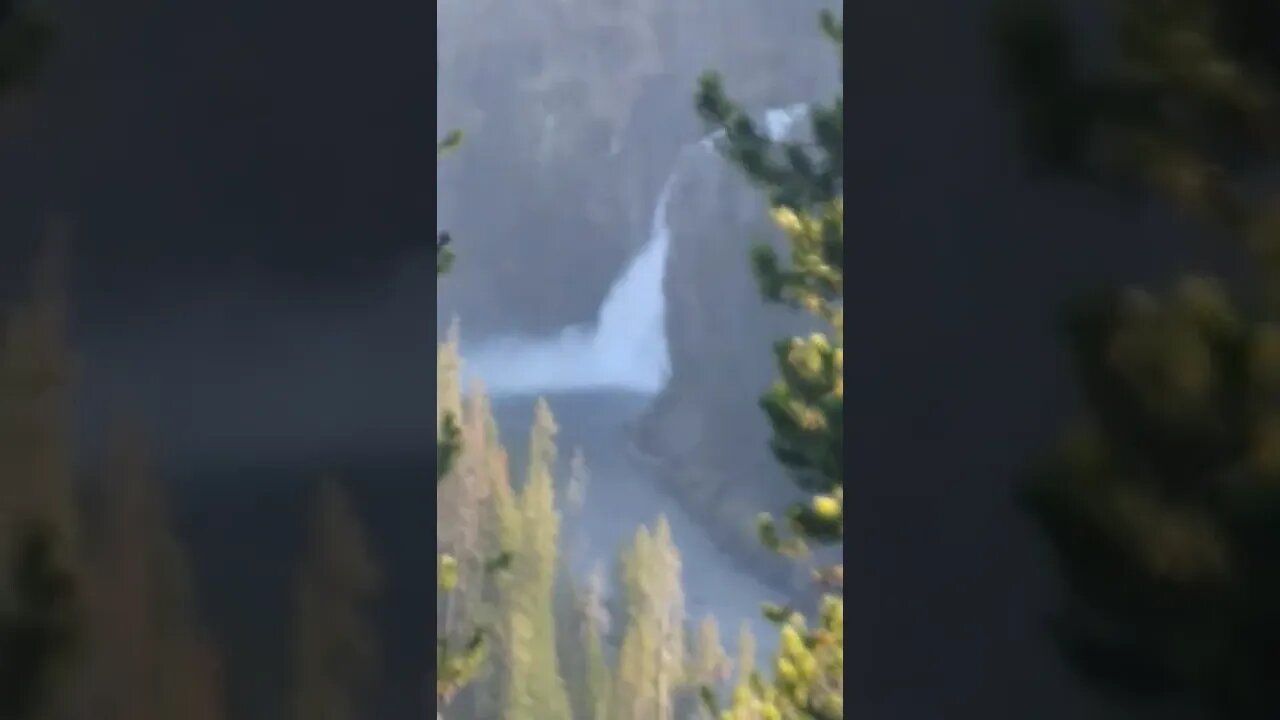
[995,0,1280,719]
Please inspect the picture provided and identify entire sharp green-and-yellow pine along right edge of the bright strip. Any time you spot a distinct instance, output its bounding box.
[698,7,845,720]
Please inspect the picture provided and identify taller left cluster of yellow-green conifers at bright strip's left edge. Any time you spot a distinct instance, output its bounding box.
[436,329,570,720]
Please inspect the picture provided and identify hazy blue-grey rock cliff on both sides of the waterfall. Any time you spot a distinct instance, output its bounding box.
[438,0,838,573]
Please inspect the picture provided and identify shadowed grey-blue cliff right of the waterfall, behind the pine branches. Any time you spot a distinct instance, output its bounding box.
[636,137,809,591]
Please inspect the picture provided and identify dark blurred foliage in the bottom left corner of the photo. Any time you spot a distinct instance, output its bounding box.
[0,527,81,720]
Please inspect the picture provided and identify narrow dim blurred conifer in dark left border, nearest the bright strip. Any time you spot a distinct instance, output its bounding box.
[293,479,381,720]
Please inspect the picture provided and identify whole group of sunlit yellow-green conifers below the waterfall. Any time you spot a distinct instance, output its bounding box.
[438,333,747,720]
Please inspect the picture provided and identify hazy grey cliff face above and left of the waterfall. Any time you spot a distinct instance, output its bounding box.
[436,0,836,334]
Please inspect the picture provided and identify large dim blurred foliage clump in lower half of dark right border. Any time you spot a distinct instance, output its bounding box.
[1021,279,1280,717]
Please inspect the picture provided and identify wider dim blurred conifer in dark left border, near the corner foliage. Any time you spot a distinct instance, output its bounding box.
[86,423,224,720]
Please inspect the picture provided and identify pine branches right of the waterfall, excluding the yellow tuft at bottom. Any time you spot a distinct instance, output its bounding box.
[698,13,845,542]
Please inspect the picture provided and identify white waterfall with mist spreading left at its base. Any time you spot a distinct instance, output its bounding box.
[462,104,808,397]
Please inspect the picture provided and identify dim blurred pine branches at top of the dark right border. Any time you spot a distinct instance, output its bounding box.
[992,0,1280,231]
